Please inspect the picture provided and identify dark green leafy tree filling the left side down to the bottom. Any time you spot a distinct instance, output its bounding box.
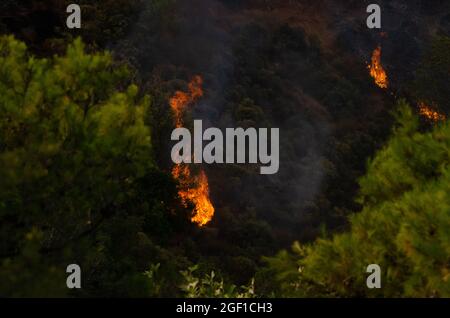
[0,37,186,296]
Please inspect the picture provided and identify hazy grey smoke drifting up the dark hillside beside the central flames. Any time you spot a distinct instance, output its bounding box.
[111,0,329,240]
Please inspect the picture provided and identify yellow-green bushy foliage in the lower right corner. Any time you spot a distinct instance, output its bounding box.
[268,101,450,297]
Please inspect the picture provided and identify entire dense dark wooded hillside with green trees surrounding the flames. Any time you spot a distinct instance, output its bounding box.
[0,0,450,297]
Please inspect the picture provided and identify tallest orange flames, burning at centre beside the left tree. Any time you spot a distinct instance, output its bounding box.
[169,76,214,226]
